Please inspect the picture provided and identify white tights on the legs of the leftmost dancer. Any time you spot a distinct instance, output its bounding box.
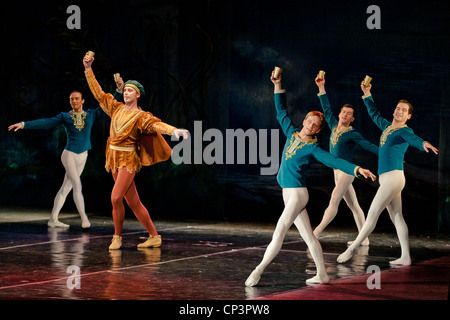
[50,149,88,225]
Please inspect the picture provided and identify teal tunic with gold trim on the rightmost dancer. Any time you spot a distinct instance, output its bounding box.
[363,96,425,175]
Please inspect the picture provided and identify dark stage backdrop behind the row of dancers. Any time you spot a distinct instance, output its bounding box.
[0,0,450,232]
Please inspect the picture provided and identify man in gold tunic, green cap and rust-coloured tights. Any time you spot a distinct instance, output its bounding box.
[83,54,189,250]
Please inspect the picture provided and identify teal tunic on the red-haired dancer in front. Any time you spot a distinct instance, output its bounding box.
[274,93,357,188]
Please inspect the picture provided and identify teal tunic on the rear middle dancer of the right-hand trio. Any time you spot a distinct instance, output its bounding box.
[319,93,378,161]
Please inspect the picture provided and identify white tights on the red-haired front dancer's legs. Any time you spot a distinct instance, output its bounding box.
[245,188,329,287]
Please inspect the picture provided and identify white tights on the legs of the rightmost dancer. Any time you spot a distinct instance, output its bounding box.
[338,170,411,265]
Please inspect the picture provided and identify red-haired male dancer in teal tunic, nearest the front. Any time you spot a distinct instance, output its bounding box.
[245,72,375,287]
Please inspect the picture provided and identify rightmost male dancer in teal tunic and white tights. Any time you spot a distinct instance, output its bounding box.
[337,81,439,265]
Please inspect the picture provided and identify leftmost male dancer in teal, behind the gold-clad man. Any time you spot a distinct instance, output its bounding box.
[8,78,123,228]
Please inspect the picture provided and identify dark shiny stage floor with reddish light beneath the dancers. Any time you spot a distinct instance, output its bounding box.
[0,208,450,300]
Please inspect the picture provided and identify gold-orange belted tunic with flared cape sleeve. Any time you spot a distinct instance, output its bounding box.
[85,69,176,173]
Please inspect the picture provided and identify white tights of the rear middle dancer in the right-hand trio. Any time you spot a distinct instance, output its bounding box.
[314,169,365,237]
